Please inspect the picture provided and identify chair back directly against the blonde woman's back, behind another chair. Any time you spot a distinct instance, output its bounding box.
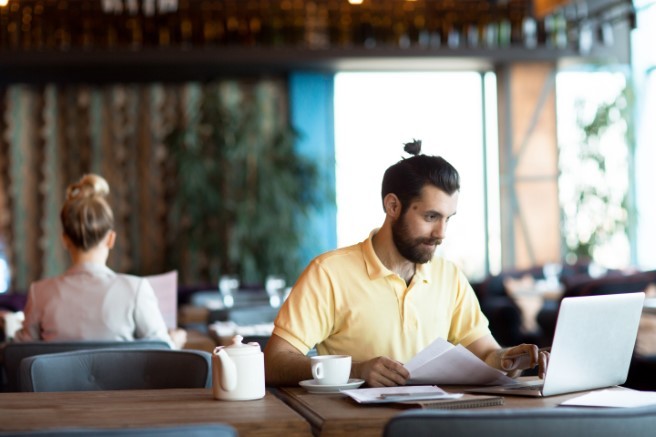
[0,340,171,391]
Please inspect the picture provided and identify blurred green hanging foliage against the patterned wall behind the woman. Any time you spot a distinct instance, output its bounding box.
[167,82,323,284]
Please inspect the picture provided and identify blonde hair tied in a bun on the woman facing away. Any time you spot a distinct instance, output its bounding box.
[60,174,114,252]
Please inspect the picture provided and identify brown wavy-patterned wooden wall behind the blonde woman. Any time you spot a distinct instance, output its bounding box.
[0,79,287,292]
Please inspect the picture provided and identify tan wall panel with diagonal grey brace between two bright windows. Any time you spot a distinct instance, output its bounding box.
[497,59,561,268]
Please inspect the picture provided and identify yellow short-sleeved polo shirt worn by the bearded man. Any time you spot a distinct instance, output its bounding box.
[273,233,490,363]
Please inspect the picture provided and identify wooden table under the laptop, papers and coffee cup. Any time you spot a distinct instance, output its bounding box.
[272,387,608,437]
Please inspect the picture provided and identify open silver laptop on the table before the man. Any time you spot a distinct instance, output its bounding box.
[465,293,645,397]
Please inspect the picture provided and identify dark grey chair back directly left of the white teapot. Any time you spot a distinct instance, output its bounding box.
[19,348,212,392]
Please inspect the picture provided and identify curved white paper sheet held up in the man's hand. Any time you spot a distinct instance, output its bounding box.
[405,338,514,385]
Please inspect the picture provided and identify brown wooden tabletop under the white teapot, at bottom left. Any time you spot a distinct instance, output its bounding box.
[0,389,310,437]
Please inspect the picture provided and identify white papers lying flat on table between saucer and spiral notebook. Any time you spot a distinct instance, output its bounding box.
[340,385,462,404]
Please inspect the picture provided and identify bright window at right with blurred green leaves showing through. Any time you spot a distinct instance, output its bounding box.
[556,71,630,268]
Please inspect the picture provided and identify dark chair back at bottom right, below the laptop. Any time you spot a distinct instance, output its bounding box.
[383,405,656,437]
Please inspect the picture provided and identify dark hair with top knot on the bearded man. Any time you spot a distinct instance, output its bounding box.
[382,139,460,213]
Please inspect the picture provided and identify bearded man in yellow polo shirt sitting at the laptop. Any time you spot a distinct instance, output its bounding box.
[264,144,548,387]
